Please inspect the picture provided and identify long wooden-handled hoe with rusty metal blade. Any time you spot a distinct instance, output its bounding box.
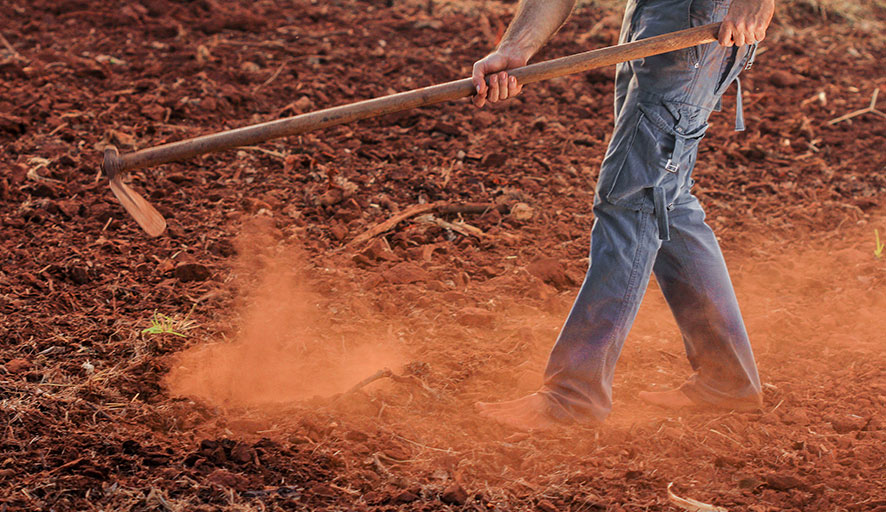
[102,23,720,236]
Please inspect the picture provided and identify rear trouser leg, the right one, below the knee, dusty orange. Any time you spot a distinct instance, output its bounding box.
[653,194,760,404]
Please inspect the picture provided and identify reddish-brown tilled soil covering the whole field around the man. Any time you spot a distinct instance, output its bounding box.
[0,0,886,512]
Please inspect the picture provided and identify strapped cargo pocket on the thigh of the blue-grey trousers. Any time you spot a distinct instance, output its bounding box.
[601,102,708,213]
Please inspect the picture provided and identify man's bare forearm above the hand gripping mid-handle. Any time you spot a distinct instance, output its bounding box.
[498,0,576,59]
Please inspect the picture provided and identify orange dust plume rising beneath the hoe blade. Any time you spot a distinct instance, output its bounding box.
[166,224,402,407]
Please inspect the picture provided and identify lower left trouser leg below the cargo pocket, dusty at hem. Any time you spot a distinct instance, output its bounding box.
[540,196,660,421]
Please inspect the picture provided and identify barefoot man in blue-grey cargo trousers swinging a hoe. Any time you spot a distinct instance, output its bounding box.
[473,0,775,429]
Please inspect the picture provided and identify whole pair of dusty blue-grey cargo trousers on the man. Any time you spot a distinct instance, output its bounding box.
[540,0,759,421]
